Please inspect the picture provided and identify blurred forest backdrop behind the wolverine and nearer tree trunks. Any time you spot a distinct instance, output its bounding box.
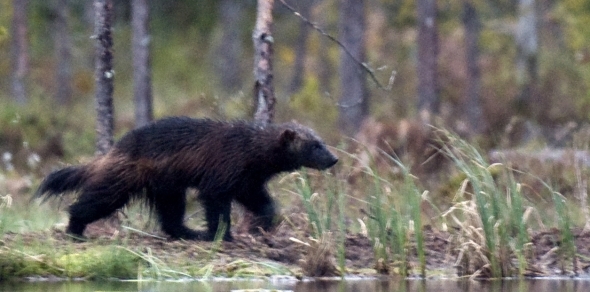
[0,0,590,162]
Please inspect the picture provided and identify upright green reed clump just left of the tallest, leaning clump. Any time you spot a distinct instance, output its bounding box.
[350,146,426,276]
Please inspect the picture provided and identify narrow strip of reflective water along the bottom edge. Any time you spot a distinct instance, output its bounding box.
[0,279,590,292]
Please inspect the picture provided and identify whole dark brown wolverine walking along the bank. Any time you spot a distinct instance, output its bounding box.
[37,117,338,240]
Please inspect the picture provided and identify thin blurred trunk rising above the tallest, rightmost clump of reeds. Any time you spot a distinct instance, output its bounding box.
[463,0,484,134]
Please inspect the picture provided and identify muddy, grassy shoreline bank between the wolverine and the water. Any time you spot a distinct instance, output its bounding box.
[0,218,590,281]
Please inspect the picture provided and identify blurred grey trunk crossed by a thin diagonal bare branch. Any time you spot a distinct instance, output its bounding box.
[338,0,369,136]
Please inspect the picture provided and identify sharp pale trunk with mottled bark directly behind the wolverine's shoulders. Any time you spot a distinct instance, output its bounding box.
[252,0,276,124]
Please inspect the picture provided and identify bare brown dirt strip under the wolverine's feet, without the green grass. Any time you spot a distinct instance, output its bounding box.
[1,214,590,277]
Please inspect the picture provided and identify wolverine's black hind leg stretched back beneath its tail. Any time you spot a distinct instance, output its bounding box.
[66,189,129,238]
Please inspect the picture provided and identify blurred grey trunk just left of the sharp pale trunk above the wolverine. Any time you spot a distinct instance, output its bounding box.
[217,0,244,92]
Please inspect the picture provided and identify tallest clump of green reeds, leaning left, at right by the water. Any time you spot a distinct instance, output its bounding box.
[440,131,528,278]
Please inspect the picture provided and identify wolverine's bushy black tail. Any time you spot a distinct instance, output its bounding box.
[35,166,86,199]
